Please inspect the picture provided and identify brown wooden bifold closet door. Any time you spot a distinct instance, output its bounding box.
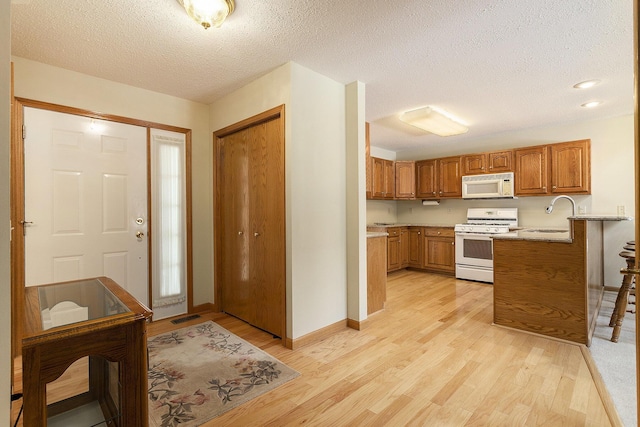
[214,107,286,338]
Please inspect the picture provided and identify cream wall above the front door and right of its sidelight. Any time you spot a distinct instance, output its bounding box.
[12,57,213,305]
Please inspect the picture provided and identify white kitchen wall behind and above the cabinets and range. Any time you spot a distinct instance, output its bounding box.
[367,115,635,286]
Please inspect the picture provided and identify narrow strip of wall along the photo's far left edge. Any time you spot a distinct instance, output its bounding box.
[0,1,12,425]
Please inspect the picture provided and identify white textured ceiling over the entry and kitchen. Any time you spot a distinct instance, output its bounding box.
[11,0,633,151]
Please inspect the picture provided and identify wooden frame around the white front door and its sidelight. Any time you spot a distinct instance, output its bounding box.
[10,97,193,359]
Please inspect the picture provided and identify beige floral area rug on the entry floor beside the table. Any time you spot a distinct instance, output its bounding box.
[148,321,300,427]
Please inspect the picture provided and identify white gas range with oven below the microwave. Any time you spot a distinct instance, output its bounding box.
[454,208,518,283]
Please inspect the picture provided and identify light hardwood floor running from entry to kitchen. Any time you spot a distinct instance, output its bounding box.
[11,271,617,427]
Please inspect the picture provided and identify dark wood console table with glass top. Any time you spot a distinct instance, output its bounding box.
[22,277,152,427]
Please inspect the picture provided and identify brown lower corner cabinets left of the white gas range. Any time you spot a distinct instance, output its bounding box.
[370,226,456,275]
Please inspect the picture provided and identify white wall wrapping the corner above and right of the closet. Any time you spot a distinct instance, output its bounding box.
[210,63,347,339]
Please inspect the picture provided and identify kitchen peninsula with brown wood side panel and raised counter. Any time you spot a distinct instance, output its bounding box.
[493,215,632,345]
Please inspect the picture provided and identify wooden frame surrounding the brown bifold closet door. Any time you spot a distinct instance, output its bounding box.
[213,104,291,348]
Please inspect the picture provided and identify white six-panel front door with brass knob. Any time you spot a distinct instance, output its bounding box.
[24,107,149,304]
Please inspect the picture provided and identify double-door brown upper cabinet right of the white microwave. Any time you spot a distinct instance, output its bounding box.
[515,139,591,196]
